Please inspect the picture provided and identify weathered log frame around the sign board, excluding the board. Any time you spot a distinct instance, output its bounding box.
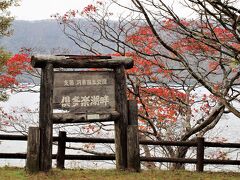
[31,55,133,172]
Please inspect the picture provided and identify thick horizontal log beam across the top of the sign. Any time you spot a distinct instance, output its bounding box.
[31,55,133,69]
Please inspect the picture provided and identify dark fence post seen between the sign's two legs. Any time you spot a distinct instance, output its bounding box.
[57,131,66,169]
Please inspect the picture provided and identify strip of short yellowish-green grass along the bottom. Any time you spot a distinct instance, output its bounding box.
[0,167,240,180]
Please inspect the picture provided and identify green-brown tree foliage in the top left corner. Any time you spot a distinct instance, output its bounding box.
[0,0,18,37]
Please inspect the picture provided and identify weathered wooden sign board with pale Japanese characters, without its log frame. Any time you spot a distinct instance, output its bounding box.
[53,71,116,114]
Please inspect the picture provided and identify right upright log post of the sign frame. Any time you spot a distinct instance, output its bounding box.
[115,65,128,170]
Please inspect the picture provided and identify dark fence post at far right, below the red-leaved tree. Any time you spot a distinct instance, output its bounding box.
[196,137,204,172]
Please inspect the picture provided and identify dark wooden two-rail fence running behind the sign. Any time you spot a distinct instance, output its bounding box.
[0,132,240,172]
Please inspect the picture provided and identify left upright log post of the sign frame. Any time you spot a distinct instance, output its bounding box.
[39,63,53,172]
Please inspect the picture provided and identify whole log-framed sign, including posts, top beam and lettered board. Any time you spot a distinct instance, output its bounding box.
[31,55,133,172]
